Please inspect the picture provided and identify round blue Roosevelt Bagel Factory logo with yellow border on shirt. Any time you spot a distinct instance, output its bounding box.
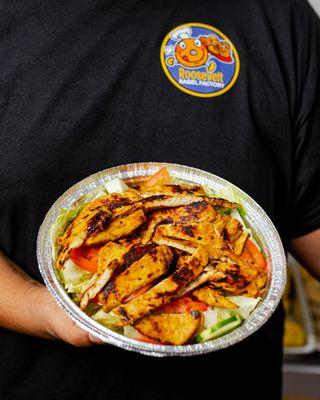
[160,22,240,97]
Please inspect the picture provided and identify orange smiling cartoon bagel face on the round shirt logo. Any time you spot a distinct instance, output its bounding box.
[175,38,208,68]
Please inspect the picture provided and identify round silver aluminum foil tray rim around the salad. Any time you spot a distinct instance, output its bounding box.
[37,162,286,357]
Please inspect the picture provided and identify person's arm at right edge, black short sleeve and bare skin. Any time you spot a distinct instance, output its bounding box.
[288,2,320,280]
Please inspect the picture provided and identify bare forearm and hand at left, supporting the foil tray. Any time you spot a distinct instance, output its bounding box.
[0,252,101,347]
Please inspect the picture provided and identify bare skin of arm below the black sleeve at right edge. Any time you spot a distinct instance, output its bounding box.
[290,229,320,281]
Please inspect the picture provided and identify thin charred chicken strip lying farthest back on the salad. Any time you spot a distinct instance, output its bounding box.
[136,184,205,197]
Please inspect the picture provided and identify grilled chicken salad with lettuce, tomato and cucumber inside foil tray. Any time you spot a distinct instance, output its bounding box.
[50,168,267,345]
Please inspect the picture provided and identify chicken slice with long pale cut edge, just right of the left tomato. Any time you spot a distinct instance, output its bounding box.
[80,242,150,310]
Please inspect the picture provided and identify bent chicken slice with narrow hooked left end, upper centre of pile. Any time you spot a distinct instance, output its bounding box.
[142,201,216,243]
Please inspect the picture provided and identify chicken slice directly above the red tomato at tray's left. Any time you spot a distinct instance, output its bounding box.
[85,205,146,246]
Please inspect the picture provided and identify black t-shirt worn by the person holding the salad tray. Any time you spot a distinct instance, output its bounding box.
[0,0,320,400]
